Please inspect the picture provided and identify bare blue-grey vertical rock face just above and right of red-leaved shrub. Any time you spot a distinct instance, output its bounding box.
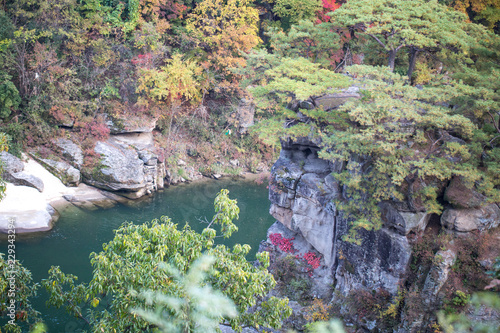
[269,139,422,295]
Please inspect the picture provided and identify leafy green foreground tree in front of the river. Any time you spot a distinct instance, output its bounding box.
[42,190,291,332]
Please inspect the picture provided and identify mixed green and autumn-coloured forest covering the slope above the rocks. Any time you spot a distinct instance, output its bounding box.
[0,0,500,220]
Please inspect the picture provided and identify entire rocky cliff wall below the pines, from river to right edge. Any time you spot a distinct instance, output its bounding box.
[266,95,500,332]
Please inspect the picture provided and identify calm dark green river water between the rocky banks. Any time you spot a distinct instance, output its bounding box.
[0,179,274,332]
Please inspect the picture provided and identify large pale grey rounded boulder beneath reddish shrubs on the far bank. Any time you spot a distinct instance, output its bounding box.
[83,141,146,196]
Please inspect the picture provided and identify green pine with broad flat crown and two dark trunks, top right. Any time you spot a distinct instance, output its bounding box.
[332,0,472,78]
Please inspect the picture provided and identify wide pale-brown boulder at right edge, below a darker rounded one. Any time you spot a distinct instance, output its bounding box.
[441,203,500,232]
